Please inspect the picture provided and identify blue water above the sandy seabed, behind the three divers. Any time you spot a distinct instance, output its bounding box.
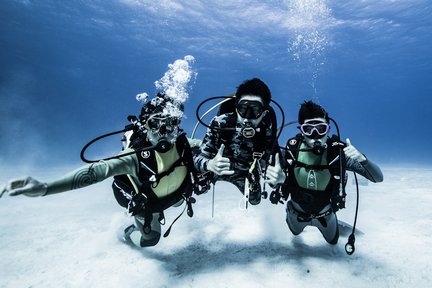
[0,0,432,166]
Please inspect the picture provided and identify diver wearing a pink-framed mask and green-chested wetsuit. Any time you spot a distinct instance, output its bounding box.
[270,101,383,245]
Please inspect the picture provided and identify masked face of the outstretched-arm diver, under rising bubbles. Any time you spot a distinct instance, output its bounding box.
[145,114,180,145]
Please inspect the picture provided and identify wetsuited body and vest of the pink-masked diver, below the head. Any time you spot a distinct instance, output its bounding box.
[282,137,383,244]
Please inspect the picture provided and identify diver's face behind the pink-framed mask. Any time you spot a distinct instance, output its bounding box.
[299,117,330,147]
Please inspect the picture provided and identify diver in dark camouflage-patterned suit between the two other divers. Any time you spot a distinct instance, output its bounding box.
[194,78,285,207]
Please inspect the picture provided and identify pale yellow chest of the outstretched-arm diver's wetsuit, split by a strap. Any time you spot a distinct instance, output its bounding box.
[152,145,187,198]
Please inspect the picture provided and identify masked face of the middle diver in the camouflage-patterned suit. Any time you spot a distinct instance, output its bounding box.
[236,95,266,126]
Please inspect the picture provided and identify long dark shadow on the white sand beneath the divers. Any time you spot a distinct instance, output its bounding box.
[141,232,368,278]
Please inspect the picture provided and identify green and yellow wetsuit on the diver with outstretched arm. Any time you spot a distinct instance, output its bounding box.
[46,135,192,247]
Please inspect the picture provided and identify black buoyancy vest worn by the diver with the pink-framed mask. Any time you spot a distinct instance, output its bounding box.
[281,134,347,215]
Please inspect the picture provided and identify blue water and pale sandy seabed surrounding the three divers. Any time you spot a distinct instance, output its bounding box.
[0,0,432,288]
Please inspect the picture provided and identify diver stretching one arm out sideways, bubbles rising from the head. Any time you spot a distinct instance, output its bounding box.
[0,93,195,247]
